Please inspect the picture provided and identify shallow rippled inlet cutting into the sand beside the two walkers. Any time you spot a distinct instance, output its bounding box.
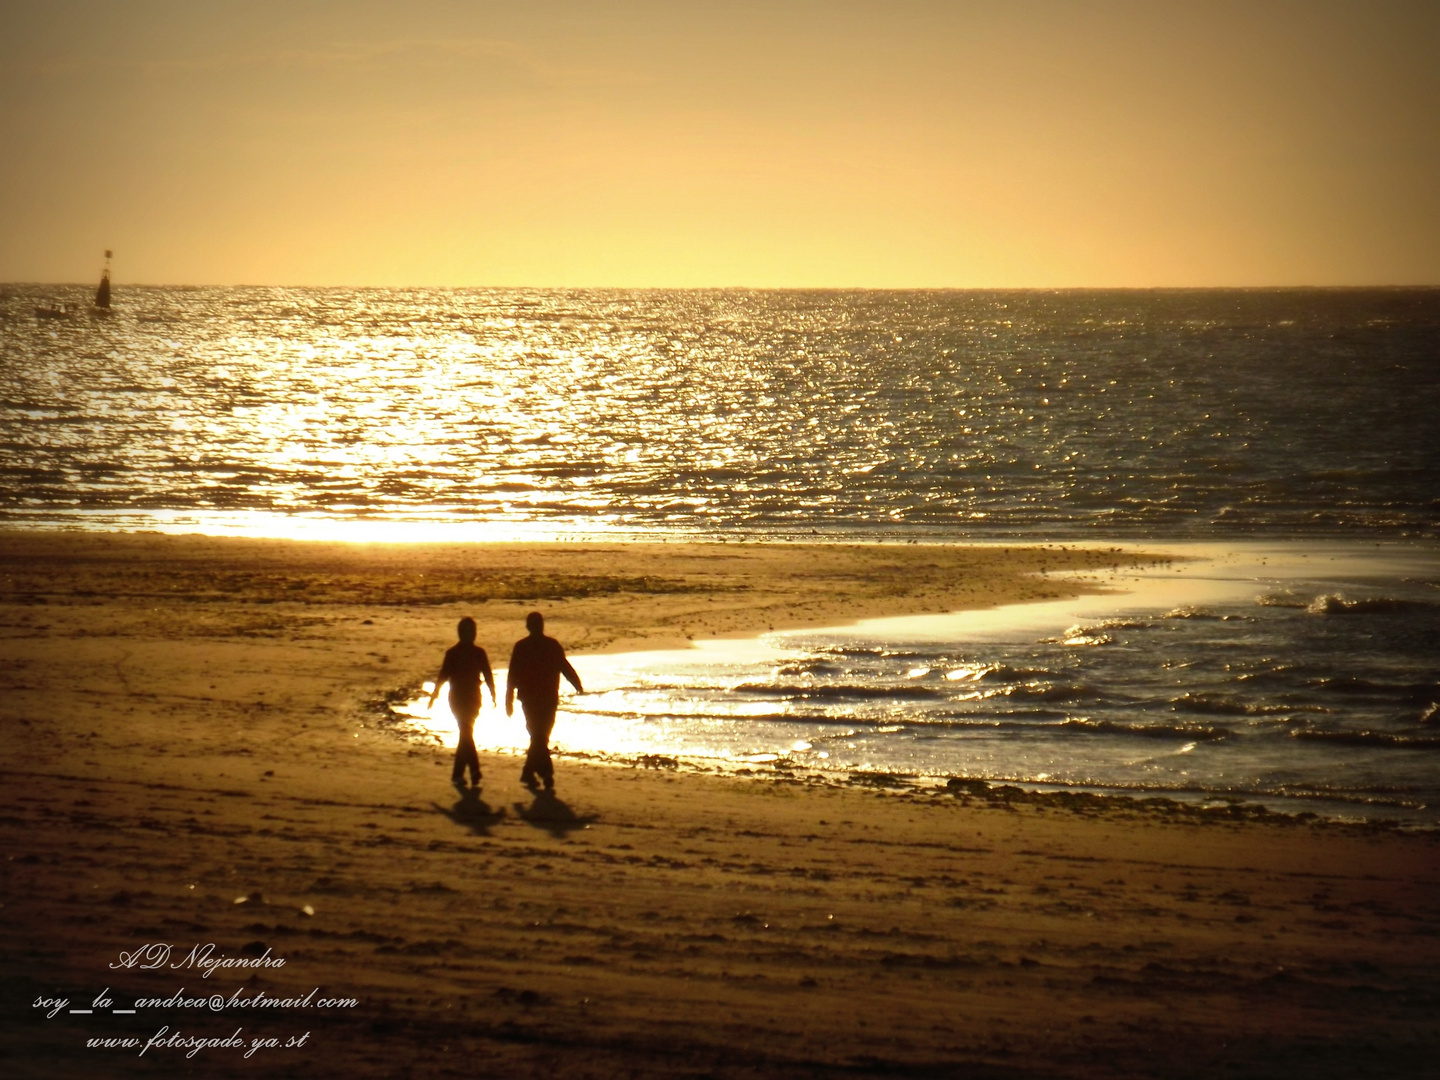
[380,543,1440,829]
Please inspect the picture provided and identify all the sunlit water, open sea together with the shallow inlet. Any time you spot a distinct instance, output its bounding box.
[0,285,1440,825]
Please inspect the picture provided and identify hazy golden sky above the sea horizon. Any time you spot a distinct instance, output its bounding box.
[0,0,1440,288]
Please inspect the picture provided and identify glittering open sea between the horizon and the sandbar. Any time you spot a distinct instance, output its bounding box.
[0,287,1440,537]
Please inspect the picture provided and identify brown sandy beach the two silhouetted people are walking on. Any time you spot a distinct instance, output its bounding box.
[0,533,1440,1079]
